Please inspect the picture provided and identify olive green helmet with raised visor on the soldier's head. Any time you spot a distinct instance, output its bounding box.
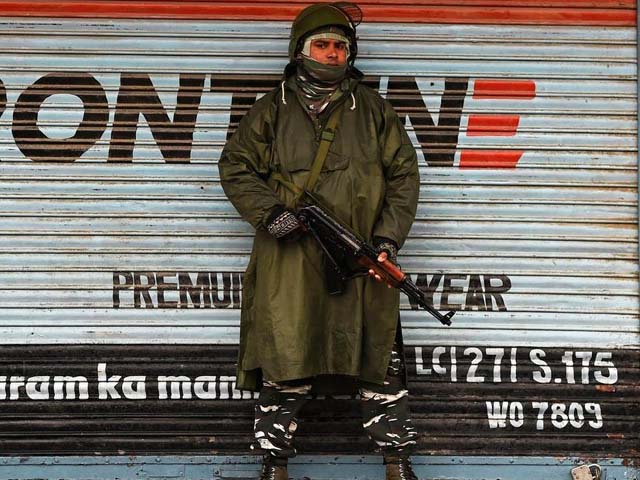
[289,2,362,64]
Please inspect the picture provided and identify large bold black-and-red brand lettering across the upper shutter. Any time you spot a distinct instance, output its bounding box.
[0,72,535,168]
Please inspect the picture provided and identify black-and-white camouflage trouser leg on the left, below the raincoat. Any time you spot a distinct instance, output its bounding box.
[253,382,311,459]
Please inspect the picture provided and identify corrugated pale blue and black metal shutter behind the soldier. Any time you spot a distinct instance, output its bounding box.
[0,1,640,464]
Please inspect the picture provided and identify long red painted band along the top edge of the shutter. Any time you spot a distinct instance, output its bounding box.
[0,0,636,27]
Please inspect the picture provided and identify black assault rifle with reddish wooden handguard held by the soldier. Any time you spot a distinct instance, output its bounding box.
[296,192,455,325]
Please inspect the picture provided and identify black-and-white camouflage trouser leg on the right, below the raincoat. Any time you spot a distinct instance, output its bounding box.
[360,344,418,455]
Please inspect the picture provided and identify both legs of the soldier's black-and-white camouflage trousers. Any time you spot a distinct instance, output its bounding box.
[254,344,418,459]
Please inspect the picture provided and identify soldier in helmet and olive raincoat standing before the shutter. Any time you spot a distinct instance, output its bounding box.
[219,2,419,480]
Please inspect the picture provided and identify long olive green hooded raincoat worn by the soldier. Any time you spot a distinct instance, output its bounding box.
[219,69,419,390]
